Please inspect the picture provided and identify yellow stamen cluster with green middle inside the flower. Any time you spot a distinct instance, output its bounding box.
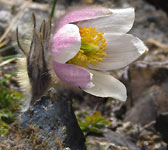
[68,27,107,68]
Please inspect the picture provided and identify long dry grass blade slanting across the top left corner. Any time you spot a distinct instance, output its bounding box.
[0,0,32,43]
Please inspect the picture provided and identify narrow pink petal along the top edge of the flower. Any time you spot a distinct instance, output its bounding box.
[58,6,111,28]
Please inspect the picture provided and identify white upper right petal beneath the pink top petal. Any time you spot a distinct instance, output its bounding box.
[77,8,135,33]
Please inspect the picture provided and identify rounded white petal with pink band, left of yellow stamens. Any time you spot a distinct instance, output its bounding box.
[50,24,81,63]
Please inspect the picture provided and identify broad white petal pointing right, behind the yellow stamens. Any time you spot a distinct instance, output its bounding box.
[89,34,147,70]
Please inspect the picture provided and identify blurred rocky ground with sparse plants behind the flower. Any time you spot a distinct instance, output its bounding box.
[0,0,168,150]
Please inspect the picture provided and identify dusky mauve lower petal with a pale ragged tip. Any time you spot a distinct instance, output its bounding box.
[53,61,94,89]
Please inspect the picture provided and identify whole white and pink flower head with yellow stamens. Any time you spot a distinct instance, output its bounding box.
[50,6,147,101]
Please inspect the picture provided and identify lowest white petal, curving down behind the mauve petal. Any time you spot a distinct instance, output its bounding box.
[84,70,127,101]
